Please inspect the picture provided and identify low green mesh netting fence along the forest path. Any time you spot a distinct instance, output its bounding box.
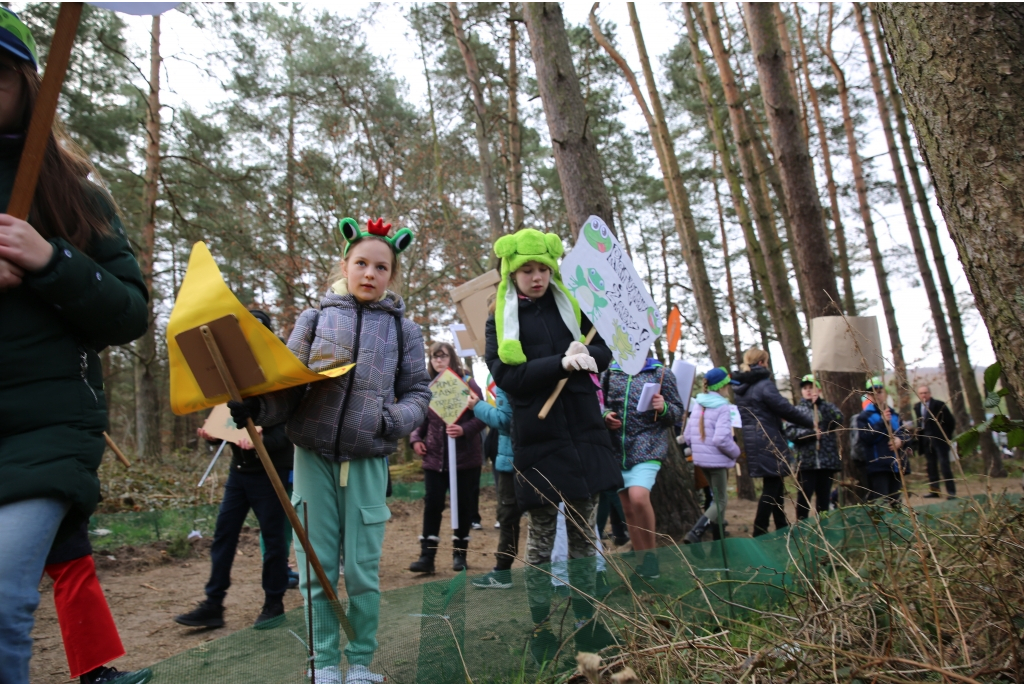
[136,496,1022,683]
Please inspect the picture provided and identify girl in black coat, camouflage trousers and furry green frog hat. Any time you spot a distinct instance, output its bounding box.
[485,228,623,662]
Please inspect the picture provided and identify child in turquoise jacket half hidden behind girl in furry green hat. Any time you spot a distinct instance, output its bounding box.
[469,388,522,590]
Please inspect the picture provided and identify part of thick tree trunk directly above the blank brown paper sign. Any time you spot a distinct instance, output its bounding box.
[744,2,842,317]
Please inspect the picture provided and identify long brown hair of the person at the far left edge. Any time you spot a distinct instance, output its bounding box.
[13,59,117,251]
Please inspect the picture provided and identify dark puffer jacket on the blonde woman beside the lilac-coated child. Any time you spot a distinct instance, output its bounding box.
[732,367,814,478]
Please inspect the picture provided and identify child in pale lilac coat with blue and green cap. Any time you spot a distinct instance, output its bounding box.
[683,368,739,545]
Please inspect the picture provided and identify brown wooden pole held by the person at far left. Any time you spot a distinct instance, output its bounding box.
[7,2,83,221]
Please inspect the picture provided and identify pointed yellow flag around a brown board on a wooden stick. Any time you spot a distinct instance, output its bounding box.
[167,243,353,415]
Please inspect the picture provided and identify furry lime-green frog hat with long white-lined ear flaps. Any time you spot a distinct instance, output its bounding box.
[495,228,583,366]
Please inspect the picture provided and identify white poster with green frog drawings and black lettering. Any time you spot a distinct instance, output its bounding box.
[561,216,663,376]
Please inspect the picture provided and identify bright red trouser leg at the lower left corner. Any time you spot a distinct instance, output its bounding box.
[46,554,125,678]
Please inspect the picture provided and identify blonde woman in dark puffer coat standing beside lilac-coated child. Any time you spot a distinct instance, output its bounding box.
[732,347,814,538]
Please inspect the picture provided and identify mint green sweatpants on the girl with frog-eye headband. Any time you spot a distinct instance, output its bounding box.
[292,446,391,669]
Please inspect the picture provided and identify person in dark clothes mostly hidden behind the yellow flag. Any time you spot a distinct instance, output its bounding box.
[174,309,295,628]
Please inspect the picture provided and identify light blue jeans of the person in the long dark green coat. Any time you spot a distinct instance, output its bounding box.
[0,498,71,683]
